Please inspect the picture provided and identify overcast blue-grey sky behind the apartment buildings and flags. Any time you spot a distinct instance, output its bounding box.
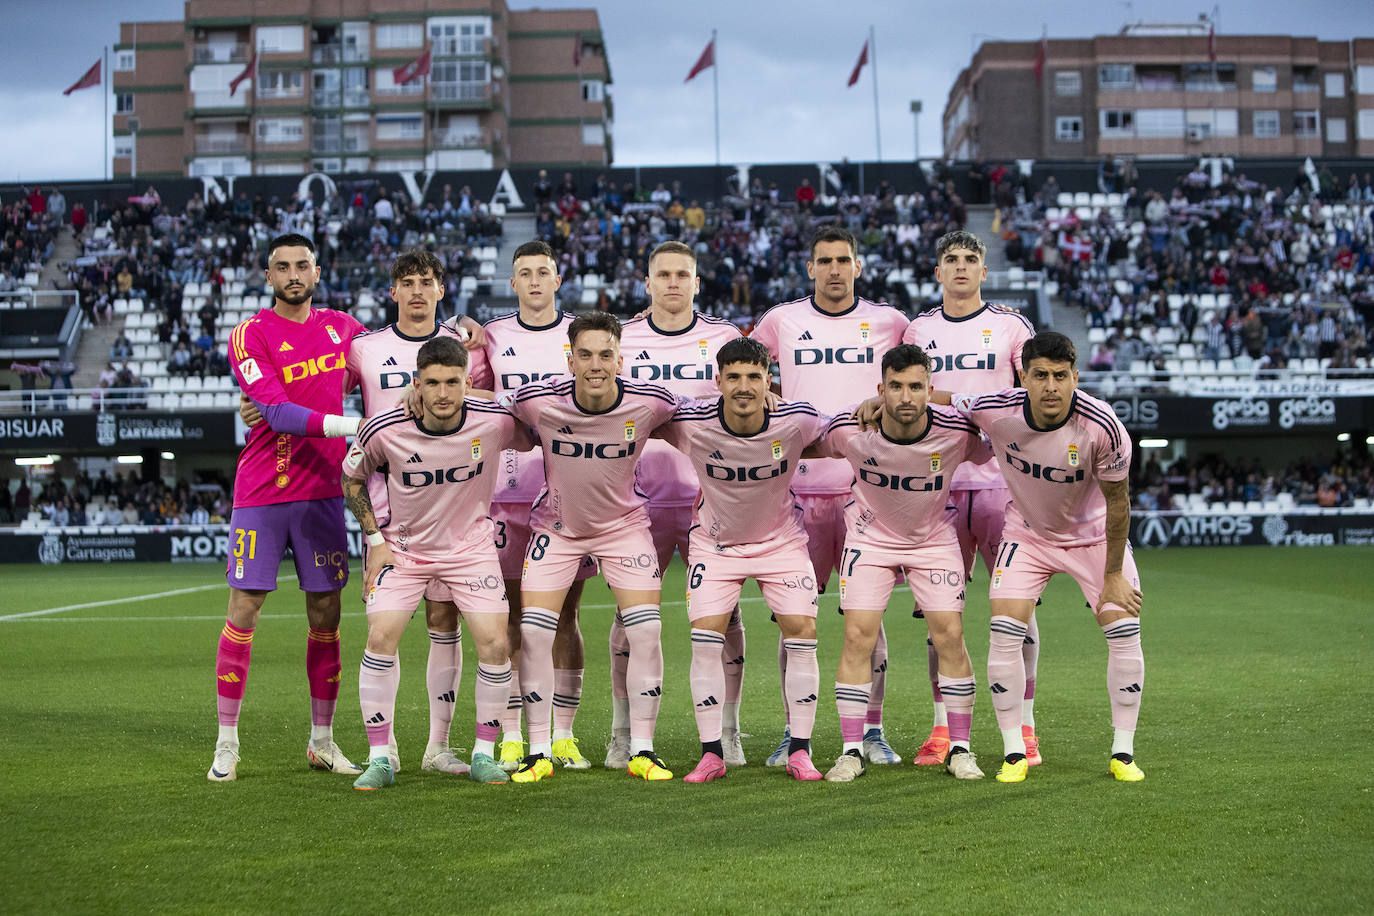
[0,0,1357,181]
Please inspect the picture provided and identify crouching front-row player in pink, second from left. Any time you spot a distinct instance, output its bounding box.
[503,312,677,783]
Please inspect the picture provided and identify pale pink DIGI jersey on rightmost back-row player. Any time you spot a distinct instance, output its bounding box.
[901,304,1035,490]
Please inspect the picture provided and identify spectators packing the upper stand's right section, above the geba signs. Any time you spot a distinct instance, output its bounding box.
[999,166,1374,372]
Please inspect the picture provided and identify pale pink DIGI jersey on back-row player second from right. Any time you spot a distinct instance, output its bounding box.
[749,297,907,496]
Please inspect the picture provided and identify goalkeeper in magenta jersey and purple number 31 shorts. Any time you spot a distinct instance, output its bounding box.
[206,233,363,781]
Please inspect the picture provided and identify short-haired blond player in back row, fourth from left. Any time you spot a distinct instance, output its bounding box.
[606,242,747,769]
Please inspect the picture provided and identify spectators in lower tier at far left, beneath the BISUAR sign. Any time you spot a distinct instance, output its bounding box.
[0,471,232,527]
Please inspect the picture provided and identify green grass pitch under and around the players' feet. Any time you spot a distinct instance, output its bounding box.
[0,548,1374,913]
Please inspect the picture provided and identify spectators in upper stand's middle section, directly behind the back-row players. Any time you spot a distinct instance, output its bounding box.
[533,169,967,327]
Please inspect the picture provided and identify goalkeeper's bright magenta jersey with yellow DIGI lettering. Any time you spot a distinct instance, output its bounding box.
[229,309,364,507]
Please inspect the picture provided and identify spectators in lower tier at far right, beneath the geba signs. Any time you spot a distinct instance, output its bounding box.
[1131,448,1374,509]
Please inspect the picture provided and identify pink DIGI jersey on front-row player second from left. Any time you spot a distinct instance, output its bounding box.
[510,379,677,537]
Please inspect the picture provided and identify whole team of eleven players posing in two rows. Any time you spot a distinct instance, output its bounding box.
[209,229,1143,788]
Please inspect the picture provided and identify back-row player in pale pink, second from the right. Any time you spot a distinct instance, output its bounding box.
[750,227,908,766]
